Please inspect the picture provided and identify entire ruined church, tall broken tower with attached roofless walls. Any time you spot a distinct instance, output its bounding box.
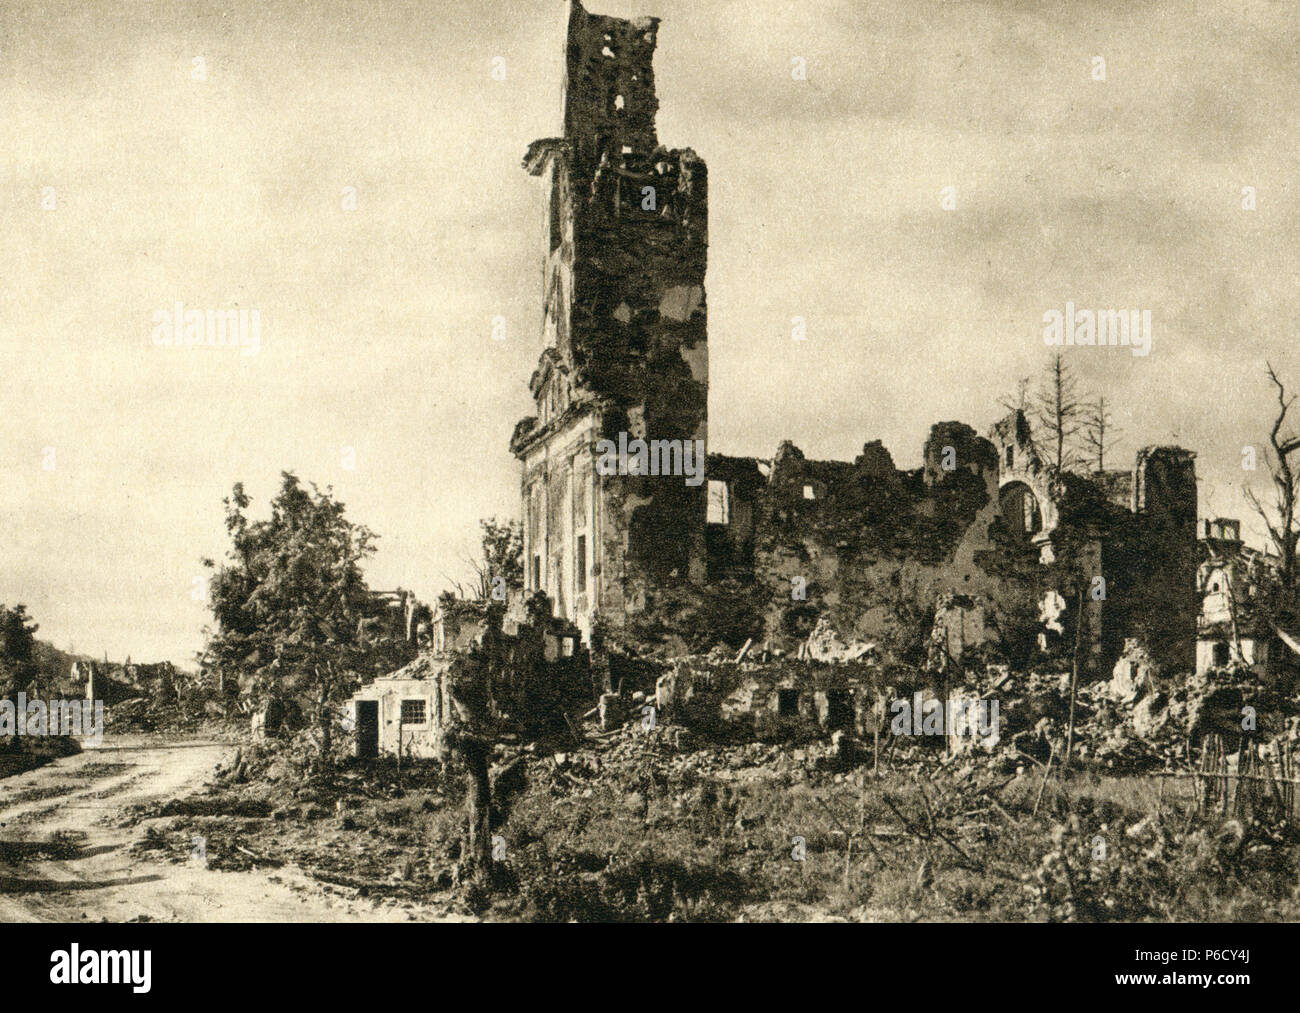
[511,0,1199,667]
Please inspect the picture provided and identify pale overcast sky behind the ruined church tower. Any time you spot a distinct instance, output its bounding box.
[0,0,1300,662]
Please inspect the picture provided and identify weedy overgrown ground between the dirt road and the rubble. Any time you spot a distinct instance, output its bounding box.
[129,727,1300,922]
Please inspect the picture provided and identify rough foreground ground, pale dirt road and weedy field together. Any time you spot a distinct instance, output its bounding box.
[10,724,1300,922]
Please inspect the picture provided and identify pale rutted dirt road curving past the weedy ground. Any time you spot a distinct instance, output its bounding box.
[0,736,452,922]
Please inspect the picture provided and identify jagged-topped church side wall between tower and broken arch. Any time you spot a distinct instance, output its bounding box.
[710,423,1041,663]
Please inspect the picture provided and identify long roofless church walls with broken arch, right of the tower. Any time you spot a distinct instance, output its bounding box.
[707,412,1197,672]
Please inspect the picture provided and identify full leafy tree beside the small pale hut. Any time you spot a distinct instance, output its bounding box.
[204,472,382,756]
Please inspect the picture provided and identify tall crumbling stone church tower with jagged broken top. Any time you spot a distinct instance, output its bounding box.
[511,0,709,635]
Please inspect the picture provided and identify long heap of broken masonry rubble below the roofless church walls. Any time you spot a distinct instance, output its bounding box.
[588,624,1300,775]
